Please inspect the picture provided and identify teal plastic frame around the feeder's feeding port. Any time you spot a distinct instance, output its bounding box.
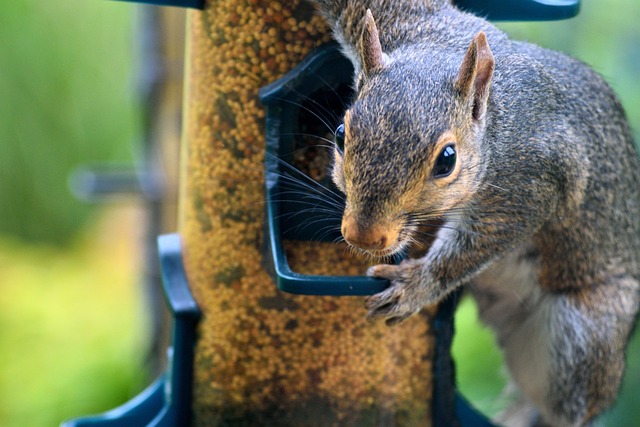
[260,45,389,296]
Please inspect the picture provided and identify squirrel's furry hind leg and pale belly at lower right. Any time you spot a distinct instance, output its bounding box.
[479,272,637,426]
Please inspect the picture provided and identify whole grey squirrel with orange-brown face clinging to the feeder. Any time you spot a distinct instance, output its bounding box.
[314,0,640,426]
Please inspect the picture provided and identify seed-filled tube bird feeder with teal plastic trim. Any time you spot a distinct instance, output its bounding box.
[67,0,579,427]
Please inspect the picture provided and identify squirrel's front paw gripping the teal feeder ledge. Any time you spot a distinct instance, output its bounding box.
[365,260,429,326]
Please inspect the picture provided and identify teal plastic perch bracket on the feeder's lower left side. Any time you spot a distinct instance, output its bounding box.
[61,234,200,427]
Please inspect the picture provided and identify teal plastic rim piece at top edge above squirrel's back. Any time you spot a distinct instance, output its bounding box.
[454,0,580,21]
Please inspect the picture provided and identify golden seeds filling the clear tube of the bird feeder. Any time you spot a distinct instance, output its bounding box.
[180,0,433,426]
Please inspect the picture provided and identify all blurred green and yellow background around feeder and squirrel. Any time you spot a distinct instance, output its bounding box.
[0,0,640,427]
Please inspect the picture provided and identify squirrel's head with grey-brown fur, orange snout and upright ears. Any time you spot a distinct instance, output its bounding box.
[332,11,494,256]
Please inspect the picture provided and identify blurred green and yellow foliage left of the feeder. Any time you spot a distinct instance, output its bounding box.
[0,0,148,427]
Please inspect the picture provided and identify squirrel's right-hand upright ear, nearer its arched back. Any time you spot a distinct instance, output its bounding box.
[456,31,495,120]
